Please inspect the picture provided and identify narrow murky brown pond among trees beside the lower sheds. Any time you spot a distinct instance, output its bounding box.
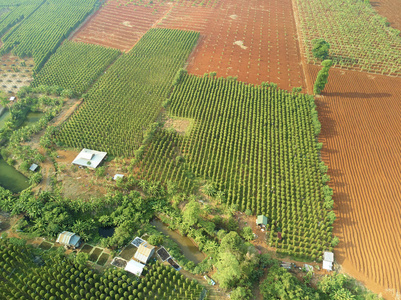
[150,220,206,264]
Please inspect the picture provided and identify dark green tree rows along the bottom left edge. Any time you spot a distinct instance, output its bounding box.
[0,240,203,300]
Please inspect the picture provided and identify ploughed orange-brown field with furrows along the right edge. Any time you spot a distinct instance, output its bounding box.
[307,65,401,299]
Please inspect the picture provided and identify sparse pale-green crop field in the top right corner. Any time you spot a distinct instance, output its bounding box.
[294,0,401,76]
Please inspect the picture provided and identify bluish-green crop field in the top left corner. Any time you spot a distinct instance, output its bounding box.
[1,0,97,71]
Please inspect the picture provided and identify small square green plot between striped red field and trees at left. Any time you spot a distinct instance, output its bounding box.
[33,41,120,94]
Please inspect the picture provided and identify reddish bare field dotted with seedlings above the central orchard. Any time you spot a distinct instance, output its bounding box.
[178,0,304,89]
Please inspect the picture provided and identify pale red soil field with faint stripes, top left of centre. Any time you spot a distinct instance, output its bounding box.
[72,0,172,51]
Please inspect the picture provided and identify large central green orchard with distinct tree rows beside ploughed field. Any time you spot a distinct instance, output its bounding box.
[139,75,333,259]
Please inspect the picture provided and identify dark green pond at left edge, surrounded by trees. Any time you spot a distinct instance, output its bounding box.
[0,159,29,193]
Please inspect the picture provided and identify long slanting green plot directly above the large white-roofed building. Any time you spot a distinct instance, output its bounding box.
[57,29,199,156]
